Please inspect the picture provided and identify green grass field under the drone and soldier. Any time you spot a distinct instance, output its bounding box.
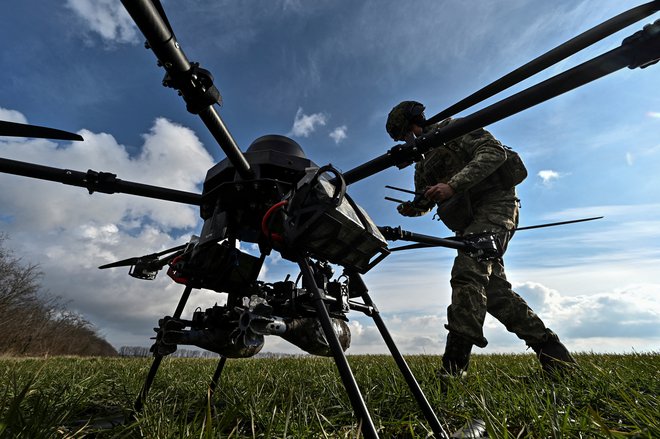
[0,353,660,439]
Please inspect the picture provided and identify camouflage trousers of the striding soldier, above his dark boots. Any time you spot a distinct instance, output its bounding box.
[446,189,553,348]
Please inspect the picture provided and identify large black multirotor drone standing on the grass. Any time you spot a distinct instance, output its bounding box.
[0,0,660,438]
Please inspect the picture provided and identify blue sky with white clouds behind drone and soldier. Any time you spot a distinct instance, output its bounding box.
[0,0,660,354]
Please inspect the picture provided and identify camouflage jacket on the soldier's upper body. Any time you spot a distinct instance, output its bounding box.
[414,119,506,231]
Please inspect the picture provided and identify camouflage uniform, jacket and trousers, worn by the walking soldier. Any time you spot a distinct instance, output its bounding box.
[415,120,556,350]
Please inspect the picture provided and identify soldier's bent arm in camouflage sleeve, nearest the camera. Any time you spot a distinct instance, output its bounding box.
[447,128,506,193]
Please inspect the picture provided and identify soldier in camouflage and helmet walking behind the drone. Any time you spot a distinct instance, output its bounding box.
[386,101,575,377]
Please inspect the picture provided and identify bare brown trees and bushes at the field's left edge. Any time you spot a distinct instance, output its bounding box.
[0,233,117,356]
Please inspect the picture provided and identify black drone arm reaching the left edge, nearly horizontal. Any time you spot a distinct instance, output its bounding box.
[0,158,202,206]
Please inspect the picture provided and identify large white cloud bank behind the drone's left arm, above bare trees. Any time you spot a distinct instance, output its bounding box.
[0,113,217,345]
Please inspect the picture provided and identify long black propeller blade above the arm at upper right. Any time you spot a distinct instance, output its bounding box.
[426,0,660,125]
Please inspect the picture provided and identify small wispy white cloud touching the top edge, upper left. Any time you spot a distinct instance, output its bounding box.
[66,0,138,43]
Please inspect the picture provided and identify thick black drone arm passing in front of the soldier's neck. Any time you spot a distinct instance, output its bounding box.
[343,20,660,184]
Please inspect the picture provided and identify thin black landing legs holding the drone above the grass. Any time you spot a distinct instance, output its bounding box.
[134,258,449,438]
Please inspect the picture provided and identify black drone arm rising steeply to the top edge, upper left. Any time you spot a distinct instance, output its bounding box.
[122,0,253,179]
